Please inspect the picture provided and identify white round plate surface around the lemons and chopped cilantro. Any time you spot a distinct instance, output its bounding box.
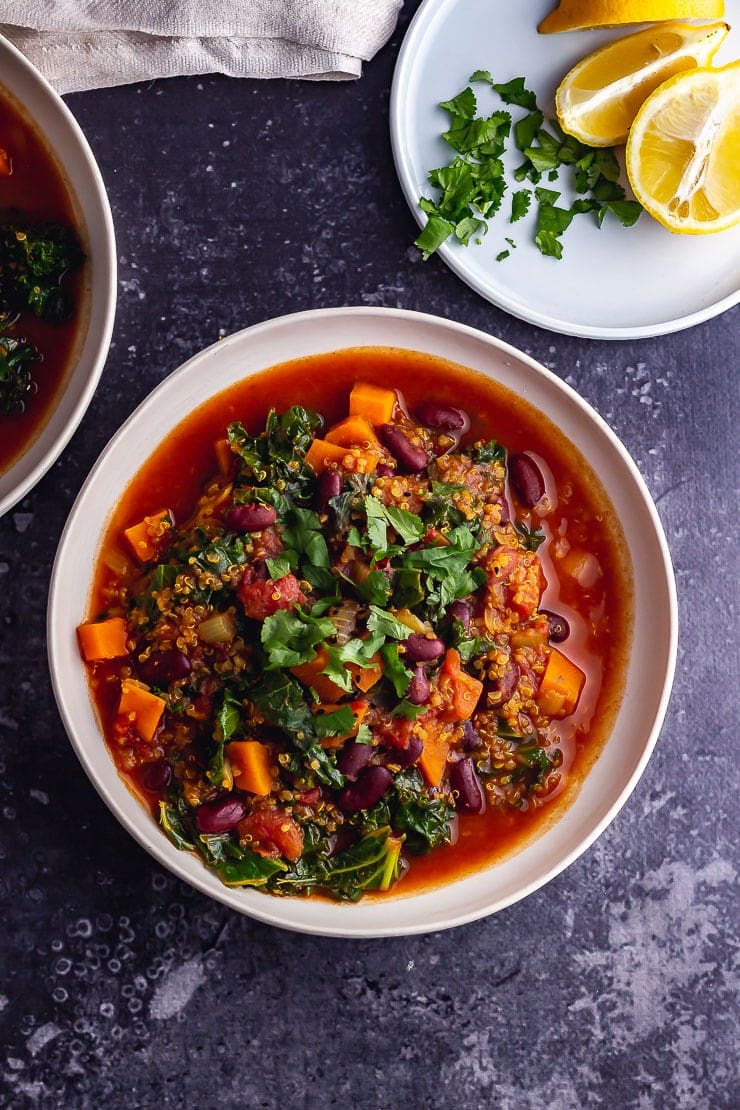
[391,0,740,340]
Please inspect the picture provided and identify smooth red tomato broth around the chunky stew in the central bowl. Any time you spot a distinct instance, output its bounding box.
[88,347,632,899]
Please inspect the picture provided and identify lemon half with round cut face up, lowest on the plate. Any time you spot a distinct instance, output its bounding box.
[627,61,740,235]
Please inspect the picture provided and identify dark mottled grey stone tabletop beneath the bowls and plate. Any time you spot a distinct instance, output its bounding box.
[0,4,740,1110]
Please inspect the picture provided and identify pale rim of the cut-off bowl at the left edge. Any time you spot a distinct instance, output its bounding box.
[0,34,118,516]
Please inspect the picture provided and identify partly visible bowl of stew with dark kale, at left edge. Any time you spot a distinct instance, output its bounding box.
[0,37,116,514]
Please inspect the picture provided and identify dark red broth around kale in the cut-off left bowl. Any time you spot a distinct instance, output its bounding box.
[0,85,87,473]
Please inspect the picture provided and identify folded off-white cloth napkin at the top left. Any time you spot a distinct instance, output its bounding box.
[0,0,403,92]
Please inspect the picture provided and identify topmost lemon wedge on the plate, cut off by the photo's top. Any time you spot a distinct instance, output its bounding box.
[537,0,724,34]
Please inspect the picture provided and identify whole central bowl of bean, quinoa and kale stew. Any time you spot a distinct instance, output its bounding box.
[48,307,677,937]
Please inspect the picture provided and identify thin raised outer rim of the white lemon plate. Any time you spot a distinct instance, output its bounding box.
[389,0,740,340]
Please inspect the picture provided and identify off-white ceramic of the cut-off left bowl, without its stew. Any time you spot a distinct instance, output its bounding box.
[0,36,116,516]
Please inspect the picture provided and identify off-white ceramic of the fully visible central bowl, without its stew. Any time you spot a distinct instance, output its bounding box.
[48,309,677,937]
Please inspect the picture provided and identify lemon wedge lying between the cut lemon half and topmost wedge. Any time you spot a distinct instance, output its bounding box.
[555,23,729,147]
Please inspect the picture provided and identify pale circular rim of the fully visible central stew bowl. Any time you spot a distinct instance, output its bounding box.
[47,305,678,939]
